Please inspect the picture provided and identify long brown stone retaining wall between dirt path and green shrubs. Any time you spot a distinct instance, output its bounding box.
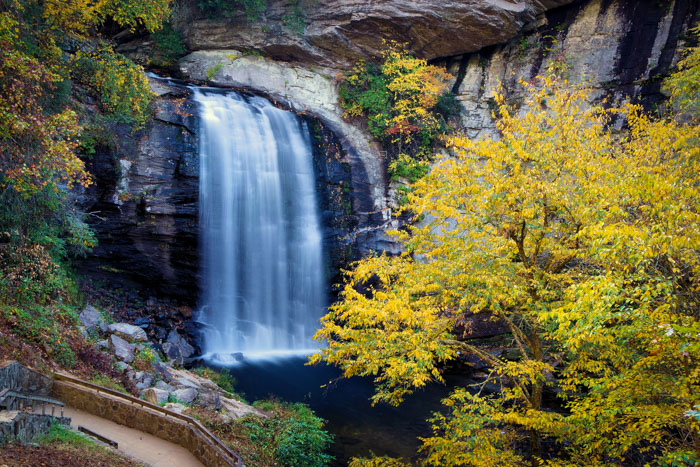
[52,381,232,467]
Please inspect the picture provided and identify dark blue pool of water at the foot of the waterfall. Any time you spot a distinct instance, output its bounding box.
[208,357,470,465]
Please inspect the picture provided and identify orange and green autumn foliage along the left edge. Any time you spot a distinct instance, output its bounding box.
[0,0,169,367]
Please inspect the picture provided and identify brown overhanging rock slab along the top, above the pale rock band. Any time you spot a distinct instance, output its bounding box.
[179,0,572,68]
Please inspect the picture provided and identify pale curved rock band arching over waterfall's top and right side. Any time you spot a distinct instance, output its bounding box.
[180,50,396,253]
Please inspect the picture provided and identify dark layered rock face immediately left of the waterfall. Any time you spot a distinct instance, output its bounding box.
[79,79,199,302]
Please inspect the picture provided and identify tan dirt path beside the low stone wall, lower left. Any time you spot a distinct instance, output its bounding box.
[65,407,203,467]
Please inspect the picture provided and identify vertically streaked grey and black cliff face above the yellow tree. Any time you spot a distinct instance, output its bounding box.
[438,0,700,138]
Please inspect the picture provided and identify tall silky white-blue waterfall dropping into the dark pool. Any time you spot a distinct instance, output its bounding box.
[194,88,325,363]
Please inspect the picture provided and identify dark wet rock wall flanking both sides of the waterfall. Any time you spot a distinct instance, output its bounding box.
[78,80,383,308]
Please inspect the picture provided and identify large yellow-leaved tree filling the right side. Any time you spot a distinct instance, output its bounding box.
[312,56,700,466]
